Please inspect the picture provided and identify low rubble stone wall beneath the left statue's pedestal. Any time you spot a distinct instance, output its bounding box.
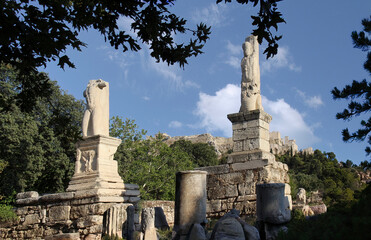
[0,190,140,239]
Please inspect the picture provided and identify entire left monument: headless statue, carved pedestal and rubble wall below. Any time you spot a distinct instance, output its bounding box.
[0,79,140,239]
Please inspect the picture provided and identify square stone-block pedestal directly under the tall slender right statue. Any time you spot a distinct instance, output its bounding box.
[228,110,272,153]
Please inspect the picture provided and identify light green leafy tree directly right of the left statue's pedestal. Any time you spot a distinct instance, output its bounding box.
[110,117,194,200]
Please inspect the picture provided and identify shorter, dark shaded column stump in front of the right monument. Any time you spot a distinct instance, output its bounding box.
[256,183,291,224]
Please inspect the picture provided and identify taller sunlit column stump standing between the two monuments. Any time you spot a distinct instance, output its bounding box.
[174,171,207,235]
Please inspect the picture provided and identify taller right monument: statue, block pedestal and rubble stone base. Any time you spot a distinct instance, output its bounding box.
[199,36,291,217]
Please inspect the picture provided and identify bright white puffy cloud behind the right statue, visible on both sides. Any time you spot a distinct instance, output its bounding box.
[194,84,319,148]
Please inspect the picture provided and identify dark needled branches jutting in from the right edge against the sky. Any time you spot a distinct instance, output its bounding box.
[331,16,371,158]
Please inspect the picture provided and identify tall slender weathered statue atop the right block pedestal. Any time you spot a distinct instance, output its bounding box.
[240,36,263,112]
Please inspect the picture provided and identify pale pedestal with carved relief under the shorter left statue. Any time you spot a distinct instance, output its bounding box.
[67,135,125,197]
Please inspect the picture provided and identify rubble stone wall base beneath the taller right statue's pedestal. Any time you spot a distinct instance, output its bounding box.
[199,162,290,218]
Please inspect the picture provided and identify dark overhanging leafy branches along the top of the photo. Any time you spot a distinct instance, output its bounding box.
[0,0,284,110]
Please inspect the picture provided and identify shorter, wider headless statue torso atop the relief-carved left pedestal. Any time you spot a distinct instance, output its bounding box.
[82,79,109,137]
